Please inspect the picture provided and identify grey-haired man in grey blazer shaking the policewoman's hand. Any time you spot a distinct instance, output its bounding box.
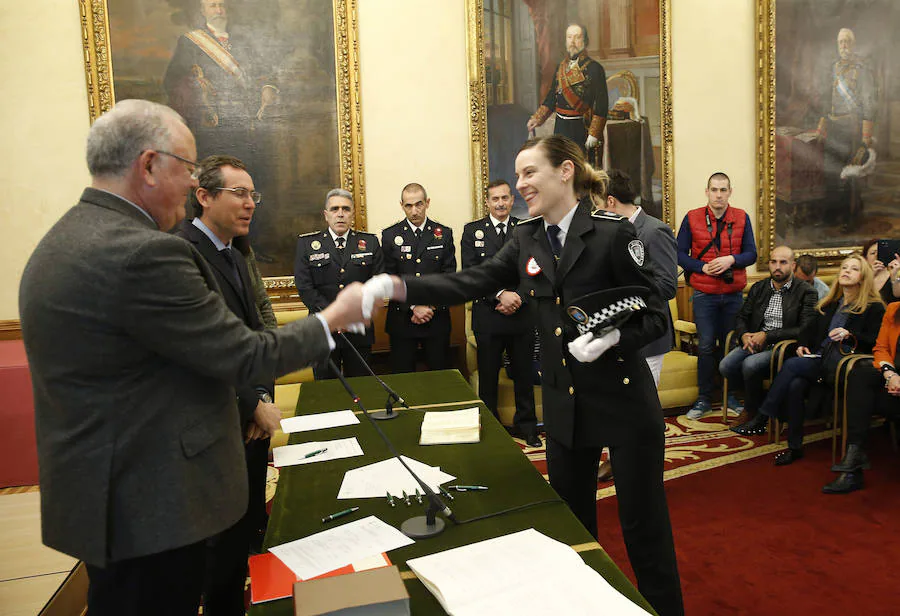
[19,101,361,616]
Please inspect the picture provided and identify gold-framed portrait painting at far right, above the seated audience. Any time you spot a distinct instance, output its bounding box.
[759,0,900,261]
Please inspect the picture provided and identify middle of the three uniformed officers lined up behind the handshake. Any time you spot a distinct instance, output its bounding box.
[381,183,456,373]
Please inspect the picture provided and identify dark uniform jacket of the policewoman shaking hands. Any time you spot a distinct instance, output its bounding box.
[406,206,665,447]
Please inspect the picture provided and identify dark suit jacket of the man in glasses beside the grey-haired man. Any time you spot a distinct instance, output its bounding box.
[173,219,275,426]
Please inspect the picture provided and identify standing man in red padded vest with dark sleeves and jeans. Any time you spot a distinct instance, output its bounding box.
[678,172,756,419]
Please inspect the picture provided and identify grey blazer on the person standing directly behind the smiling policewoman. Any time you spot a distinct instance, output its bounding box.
[634,210,678,357]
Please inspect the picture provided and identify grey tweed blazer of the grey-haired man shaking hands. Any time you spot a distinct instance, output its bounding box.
[19,188,329,566]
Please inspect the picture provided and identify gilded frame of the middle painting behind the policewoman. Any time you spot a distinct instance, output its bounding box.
[466,0,676,229]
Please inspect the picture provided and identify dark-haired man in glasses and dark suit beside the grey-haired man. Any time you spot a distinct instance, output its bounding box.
[174,155,281,616]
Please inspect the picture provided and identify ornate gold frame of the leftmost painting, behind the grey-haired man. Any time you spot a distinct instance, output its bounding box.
[78,0,368,295]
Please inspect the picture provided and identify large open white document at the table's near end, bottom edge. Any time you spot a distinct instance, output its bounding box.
[406,528,646,616]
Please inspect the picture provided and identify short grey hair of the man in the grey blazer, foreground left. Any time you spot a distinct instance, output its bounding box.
[87,99,185,177]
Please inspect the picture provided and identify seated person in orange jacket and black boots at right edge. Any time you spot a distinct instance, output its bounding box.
[822,302,900,494]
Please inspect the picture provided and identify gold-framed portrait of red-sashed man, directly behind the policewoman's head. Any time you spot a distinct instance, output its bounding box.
[469,0,674,225]
